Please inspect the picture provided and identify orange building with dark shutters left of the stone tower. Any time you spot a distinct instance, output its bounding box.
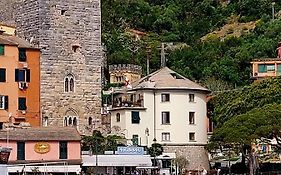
[0,30,41,129]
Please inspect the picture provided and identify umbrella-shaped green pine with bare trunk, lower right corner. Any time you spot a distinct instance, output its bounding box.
[209,104,281,175]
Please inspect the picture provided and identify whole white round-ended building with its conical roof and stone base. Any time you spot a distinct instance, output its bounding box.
[111,67,209,170]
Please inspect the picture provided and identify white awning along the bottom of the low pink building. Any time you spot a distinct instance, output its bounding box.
[8,165,81,173]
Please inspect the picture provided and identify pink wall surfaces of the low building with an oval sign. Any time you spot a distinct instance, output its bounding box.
[0,140,81,161]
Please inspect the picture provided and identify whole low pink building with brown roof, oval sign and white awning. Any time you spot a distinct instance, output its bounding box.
[0,127,82,174]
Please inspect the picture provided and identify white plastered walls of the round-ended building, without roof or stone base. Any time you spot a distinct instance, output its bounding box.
[111,90,207,146]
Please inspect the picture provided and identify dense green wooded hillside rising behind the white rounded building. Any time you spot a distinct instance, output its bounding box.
[102,0,281,91]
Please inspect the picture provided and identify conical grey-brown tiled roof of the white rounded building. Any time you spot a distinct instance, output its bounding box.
[133,67,209,92]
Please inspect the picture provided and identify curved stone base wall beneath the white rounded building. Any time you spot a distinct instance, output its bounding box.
[163,145,210,171]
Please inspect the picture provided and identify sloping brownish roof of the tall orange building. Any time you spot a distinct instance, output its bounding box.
[0,34,38,49]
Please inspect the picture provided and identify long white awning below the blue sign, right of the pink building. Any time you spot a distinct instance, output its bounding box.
[82,155,152,167]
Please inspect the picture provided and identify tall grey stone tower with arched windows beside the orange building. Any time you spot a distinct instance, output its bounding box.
[10,0,102,134]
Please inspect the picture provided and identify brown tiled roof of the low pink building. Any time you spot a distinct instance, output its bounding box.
[0,127,81,141]
